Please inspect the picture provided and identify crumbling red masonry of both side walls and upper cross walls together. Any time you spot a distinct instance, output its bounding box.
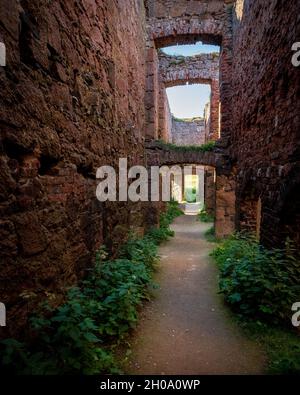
[0,0,300,334]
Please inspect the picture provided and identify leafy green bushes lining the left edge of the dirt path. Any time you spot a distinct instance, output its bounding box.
[1,202,181,374]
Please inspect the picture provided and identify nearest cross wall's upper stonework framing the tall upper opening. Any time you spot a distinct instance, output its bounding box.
[146,0,232,147]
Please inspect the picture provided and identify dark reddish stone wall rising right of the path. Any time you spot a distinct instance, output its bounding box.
[232,0,300,246]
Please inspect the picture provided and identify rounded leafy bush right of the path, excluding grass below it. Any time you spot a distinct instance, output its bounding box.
[212,234,300,323]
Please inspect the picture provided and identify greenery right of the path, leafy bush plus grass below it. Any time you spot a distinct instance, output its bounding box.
[212,234,300,374]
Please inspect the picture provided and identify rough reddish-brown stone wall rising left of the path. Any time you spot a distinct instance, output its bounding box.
[0,0,146,338]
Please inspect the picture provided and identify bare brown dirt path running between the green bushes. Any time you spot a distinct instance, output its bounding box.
[126,215,264,374]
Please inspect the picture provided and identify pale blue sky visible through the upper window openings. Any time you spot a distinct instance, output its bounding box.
[162,42,220,118]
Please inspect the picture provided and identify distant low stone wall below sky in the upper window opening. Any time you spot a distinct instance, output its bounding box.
[172,118,205,145]
